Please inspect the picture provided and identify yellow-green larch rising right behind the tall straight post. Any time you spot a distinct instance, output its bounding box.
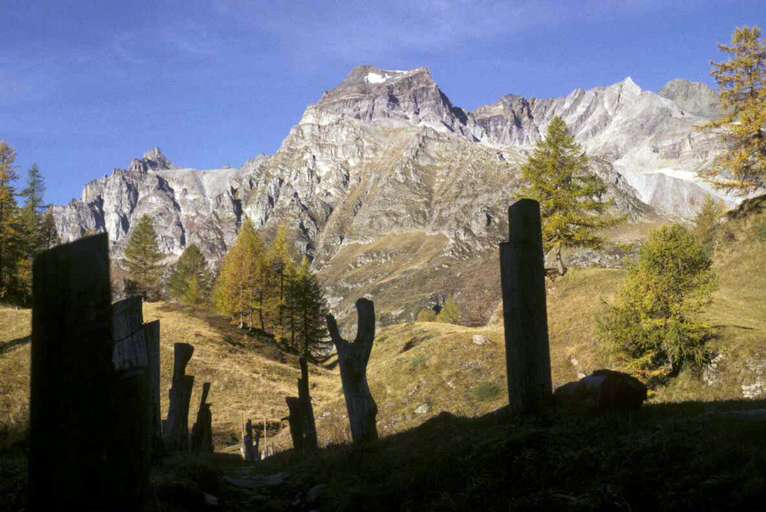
[521,117,616,275]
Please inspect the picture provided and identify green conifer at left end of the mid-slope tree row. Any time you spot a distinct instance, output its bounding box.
[125,215,163,300]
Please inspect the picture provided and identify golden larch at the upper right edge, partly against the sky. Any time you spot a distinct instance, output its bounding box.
[706,27,766,194]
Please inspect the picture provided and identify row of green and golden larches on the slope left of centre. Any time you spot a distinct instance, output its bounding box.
[124,216,330,358]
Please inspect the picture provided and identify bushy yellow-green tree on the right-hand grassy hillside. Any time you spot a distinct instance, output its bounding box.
[598,225,717,382]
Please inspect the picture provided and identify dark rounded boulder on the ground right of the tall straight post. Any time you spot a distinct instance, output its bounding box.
[554,370,646,412]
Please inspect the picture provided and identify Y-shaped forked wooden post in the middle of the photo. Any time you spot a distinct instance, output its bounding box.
[326,299,378,443]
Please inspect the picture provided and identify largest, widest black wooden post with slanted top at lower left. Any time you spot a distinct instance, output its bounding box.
[29,234,117,511]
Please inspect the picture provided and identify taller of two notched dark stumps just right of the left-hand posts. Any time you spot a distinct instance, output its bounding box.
[164,343,194,451]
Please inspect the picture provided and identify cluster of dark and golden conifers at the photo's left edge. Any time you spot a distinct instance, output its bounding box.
[0,140,59,306]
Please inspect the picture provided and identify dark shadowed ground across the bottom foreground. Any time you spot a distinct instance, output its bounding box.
[0,400,766,511]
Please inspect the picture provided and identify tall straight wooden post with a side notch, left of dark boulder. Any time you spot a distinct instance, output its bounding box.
[500,199,552,412]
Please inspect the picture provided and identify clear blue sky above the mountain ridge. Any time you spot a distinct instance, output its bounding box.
[0,0,766,203]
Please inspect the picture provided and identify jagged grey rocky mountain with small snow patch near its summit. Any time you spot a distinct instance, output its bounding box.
[54,66,736,322]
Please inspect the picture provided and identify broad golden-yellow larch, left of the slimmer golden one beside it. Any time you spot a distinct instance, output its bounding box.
[214,219,265,329]
